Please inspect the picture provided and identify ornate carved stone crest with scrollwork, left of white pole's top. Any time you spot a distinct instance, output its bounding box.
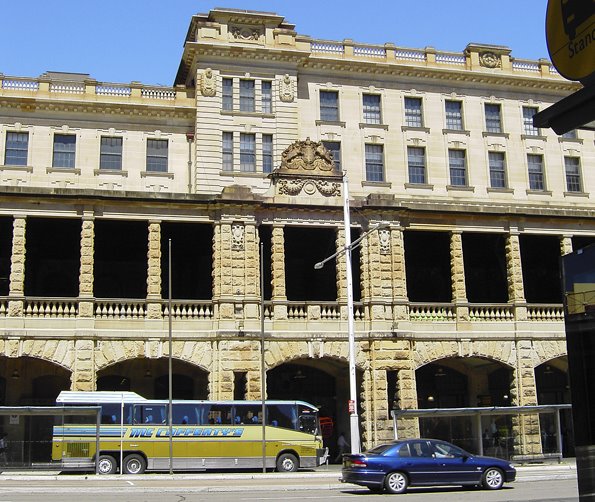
[271,138,343,197]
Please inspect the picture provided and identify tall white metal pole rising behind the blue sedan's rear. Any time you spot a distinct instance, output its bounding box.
[343,172,361,453]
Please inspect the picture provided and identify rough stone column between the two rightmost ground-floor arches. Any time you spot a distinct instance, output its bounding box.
[511,340,542,455]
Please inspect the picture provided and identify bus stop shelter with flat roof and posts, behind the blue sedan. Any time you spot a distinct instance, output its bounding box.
[391,404,572,459]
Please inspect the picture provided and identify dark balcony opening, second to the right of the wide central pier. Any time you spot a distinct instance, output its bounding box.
[463,233,508,303]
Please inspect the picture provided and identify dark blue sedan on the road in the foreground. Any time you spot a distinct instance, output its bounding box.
[341,439,516,493]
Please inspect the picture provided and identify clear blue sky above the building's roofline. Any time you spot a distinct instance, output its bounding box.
[0,0,549,85]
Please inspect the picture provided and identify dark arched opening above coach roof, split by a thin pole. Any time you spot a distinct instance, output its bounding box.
[97,357,209,399]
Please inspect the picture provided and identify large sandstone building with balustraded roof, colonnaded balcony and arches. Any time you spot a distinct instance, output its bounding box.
[0,9,595,462]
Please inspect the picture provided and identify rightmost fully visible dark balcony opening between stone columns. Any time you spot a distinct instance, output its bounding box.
[519,235,562,303]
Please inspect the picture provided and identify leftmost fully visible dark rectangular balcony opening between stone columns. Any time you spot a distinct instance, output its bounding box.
[25,218,81,298]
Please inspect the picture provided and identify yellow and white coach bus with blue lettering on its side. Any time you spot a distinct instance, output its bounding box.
[52,391,328,474]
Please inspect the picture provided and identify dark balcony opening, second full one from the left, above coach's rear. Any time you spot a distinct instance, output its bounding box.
[93,220,148,299]
